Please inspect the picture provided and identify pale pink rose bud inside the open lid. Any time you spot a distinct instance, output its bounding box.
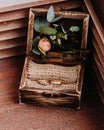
[39,38,51,52]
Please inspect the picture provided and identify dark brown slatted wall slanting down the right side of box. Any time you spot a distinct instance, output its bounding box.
[82,0,104,103]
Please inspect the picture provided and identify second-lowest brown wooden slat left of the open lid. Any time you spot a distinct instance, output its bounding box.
[0,37,27,51]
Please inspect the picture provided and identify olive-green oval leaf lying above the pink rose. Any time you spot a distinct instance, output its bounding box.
[39,26,57,36]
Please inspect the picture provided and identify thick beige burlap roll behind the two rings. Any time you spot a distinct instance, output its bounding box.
[28,61,81,83]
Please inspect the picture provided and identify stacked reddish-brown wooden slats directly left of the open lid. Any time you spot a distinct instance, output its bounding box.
[0,9,28,59]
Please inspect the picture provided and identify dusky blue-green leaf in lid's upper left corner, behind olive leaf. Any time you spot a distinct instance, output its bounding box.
[34,16,49,32]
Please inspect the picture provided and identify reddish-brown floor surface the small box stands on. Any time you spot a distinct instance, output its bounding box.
[0,55,104,130]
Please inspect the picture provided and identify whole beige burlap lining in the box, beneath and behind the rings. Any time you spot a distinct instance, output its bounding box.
[25,60,81,93]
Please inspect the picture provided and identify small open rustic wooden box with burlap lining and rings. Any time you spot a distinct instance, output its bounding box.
[19,8,89,109]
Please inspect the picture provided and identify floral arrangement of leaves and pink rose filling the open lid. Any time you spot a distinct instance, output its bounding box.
[32,6,89,61]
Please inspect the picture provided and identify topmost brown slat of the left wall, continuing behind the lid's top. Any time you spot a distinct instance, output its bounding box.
[0,1,81,22]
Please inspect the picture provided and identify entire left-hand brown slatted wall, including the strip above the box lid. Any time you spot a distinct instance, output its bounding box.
[0,0,81,59]
